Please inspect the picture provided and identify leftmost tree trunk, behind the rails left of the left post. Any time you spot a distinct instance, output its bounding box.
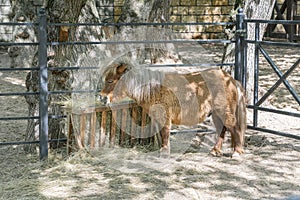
[8,0,41,152]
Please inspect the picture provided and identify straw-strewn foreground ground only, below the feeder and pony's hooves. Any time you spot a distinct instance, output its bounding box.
[0,133,300,199]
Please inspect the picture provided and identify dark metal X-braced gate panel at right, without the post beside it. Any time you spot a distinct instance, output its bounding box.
[245,17,300,139]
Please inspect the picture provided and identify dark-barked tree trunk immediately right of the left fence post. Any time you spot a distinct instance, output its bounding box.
[46,0,87,148]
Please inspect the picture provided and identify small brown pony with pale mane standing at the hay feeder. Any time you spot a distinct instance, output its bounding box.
[100,61,246,156]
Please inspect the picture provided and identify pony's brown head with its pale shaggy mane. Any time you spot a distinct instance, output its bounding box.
[100,60,164,103]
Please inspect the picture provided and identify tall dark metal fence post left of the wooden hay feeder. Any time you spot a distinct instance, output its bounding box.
[38,8,48,160]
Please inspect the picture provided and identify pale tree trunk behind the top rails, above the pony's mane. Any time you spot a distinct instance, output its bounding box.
[113,0,178,63]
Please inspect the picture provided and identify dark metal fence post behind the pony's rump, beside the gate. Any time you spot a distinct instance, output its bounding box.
[234,8,247,88]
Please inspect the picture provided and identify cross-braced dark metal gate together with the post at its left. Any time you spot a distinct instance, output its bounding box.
[235,10,300,139]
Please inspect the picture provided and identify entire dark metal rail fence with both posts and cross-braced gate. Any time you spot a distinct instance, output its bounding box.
[0,9,300,159]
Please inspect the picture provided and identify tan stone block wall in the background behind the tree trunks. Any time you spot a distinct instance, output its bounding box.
[0,0,234,41]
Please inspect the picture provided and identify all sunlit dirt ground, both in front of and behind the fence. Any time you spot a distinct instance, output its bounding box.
[0,45,300,200]
